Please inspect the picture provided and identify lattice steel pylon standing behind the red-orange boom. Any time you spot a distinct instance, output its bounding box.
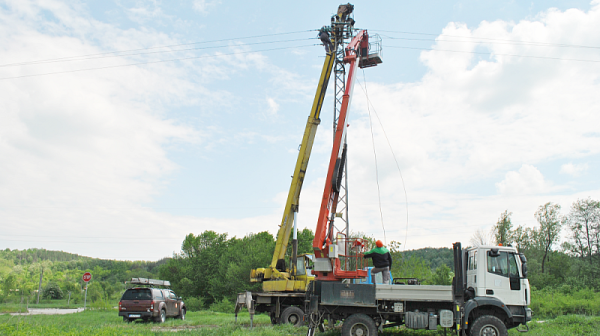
[331,11,354,237]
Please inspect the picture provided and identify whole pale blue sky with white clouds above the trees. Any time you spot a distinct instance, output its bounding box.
[0,0,600,260]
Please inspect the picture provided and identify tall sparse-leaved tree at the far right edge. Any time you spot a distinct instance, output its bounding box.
[565,198,600,264]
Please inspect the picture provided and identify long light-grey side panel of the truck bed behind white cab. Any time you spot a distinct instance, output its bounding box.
[375,284,452,302]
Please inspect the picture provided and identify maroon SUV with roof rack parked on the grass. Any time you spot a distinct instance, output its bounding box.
[119,287,186,323]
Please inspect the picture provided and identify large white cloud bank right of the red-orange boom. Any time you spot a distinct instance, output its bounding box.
[318,4,600,248]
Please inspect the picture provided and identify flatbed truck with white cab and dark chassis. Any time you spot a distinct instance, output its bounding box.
[305,243,532,336]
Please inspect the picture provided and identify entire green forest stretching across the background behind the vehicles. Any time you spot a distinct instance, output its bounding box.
[0,199,600,316]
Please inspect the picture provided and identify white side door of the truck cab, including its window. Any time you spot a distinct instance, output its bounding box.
[486,251,525,306]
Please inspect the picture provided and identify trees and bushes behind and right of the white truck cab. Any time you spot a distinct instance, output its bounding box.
[471,198,600,291]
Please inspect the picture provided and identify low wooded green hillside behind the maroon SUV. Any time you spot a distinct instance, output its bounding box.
[0,249,166,306]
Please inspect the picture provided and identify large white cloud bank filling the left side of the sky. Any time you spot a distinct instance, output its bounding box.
[0,1,236,260]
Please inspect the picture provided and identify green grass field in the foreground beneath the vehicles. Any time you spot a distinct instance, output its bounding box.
[0,310,600,336]
